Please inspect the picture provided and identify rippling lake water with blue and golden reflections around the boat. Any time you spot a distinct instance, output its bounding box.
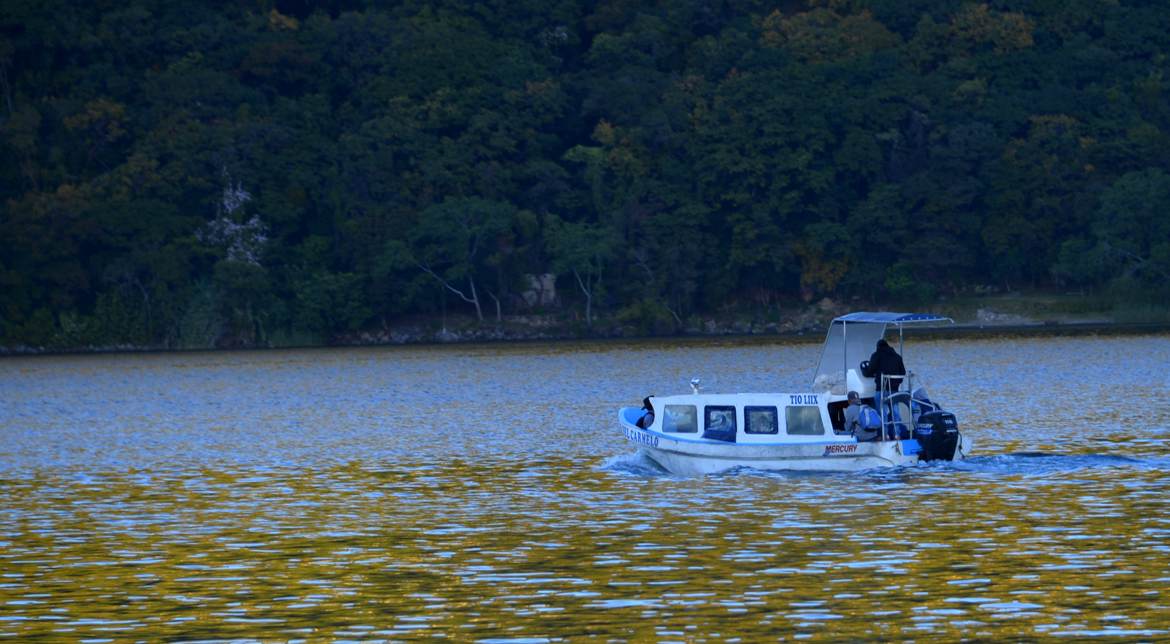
[0,336,1170,642]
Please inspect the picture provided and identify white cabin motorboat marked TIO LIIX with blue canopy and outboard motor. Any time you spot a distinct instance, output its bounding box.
[618,313,971,475]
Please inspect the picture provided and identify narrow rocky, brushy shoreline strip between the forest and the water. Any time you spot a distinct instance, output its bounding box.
[0,295,1170,357]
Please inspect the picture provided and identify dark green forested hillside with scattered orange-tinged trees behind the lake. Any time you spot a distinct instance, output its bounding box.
[0,0,1170,347]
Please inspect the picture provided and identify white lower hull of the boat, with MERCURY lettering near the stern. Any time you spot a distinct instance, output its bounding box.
[620,417,970,477]
